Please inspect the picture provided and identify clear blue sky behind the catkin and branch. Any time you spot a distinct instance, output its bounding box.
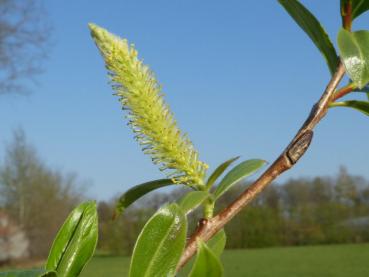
[0,0,369,199]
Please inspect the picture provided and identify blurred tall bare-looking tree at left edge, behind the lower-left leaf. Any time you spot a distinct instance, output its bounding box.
[0,131,81,257]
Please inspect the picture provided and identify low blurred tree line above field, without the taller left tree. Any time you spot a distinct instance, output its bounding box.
[99,167,369,255]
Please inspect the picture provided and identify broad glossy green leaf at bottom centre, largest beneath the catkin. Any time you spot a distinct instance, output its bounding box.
[129,204,187,277]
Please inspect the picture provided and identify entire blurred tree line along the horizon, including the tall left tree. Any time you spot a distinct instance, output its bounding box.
[0,130,369,262]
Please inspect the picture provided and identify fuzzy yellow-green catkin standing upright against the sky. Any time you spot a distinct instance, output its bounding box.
[89,24,208,186]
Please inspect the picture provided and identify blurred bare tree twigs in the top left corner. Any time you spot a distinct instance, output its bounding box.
[0,0,50,95]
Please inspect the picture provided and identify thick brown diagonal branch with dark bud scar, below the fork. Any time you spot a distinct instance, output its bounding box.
[177,63,345,270]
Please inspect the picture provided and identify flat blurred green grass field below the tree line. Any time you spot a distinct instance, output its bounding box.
[82,244,369,277]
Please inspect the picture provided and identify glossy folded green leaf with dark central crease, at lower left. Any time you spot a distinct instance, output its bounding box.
[46,201,98,277]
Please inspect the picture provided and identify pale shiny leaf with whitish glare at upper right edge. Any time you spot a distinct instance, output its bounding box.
[337,29,369,89]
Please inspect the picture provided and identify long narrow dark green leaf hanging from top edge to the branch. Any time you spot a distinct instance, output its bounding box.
[279,0,339,74]
